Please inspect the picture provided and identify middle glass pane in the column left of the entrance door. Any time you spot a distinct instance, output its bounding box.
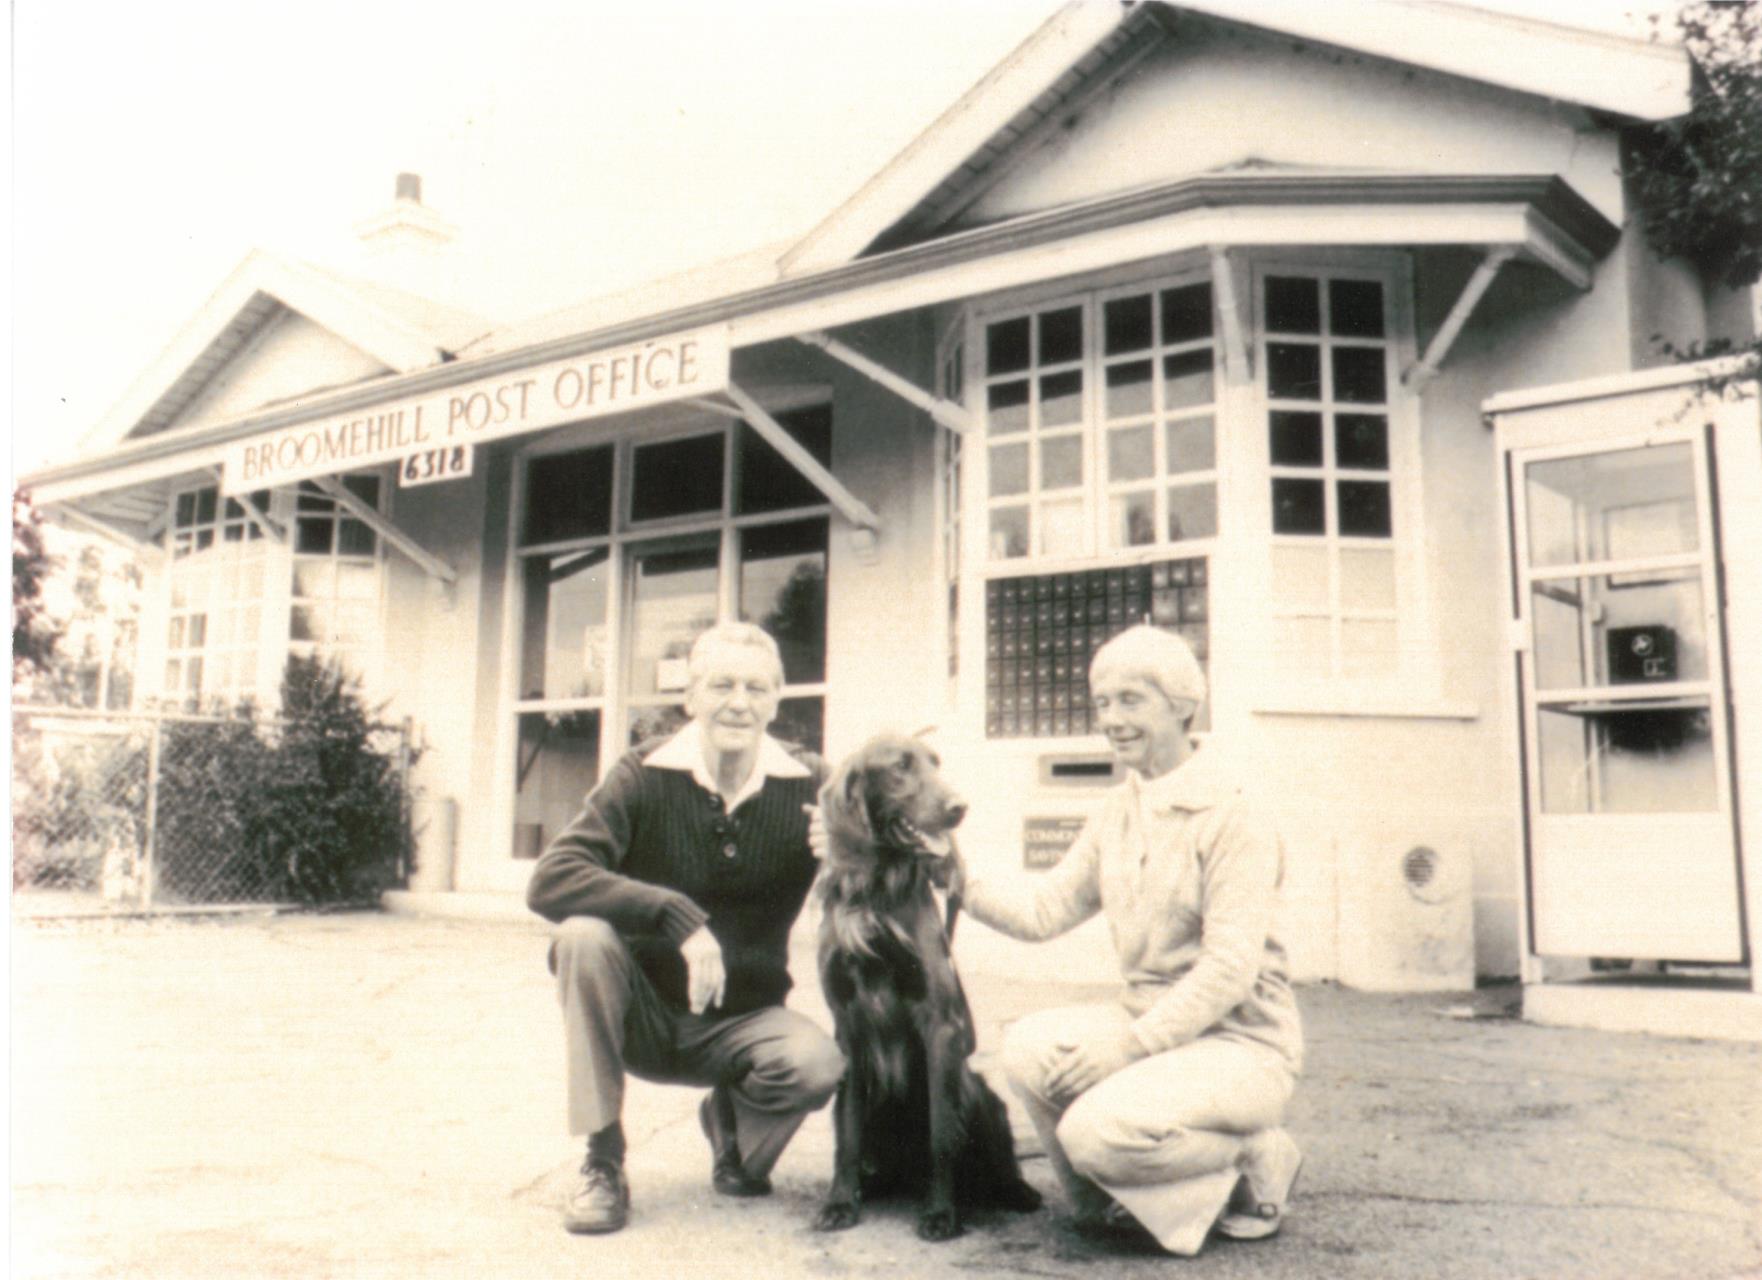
[520,548,610,698]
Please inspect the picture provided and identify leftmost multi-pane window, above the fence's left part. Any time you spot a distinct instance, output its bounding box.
[160,485,268,707]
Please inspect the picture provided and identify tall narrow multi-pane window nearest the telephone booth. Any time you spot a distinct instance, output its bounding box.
[1260,272,1399,677]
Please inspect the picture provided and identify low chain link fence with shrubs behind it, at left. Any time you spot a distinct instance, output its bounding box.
[12,705,414,910]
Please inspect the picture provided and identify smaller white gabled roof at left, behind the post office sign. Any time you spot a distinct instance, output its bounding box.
[81,249,490,450]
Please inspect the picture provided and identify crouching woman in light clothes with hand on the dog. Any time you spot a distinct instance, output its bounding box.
[966,626,1302,1255]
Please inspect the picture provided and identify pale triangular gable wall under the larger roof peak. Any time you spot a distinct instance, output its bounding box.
[962,21,1623,224]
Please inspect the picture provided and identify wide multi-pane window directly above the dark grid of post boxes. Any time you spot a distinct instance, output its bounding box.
[983,280,1218,562]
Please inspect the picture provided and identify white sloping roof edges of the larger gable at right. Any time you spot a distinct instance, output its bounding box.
[779,0,1692,277]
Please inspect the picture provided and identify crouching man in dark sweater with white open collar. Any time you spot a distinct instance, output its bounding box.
[527,622,844,1232]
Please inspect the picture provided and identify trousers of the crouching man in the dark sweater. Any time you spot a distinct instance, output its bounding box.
[552,917,844,1176]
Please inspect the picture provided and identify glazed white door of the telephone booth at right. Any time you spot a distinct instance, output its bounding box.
[1507,430,1744,963]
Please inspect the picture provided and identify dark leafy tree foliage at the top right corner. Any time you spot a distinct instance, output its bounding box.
[1626,0,1762,289]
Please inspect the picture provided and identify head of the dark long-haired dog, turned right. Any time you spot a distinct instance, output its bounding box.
[819,733,967,857]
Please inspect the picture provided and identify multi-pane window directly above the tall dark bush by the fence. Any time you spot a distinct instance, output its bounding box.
[287,474,379,673]
